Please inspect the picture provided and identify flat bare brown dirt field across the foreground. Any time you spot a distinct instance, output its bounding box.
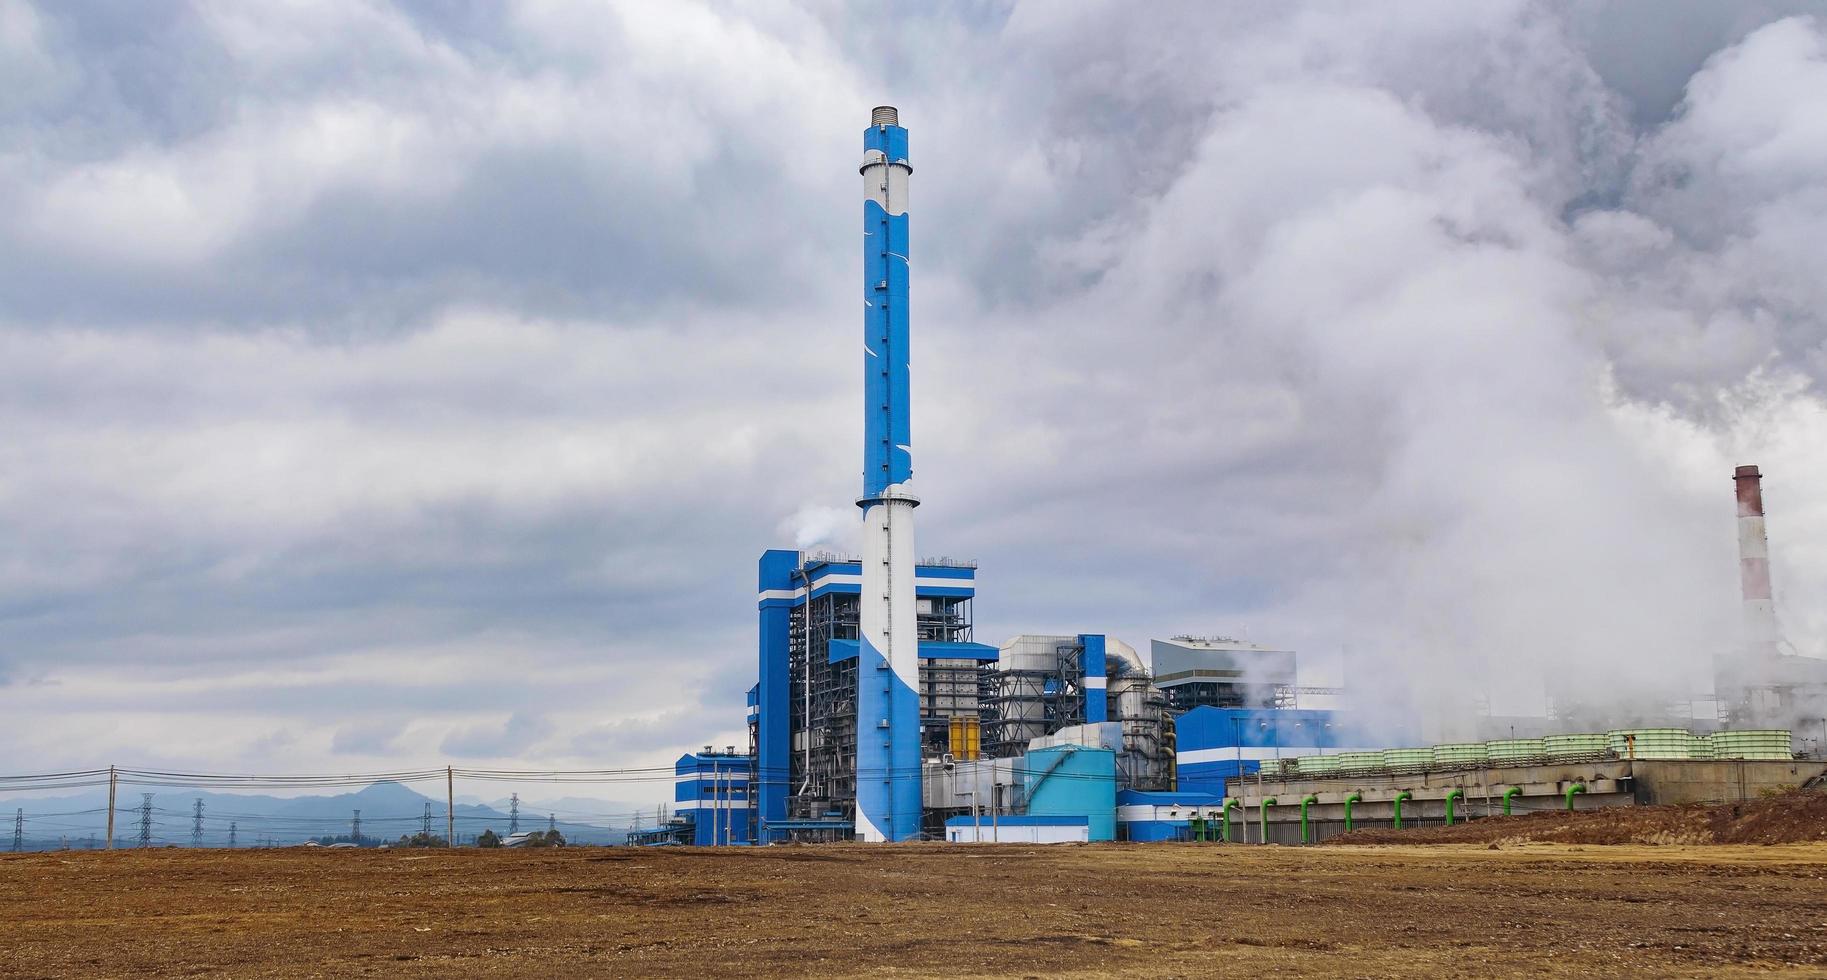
[0,845,1827,976]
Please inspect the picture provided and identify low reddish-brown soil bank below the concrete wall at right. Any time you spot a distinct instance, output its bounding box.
[1326,790,1827,845]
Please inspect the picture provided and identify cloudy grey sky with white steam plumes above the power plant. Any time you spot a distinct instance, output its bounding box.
[0,0,1827,793]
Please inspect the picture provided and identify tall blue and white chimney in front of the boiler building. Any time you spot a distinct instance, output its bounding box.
[857,106,921,841]
